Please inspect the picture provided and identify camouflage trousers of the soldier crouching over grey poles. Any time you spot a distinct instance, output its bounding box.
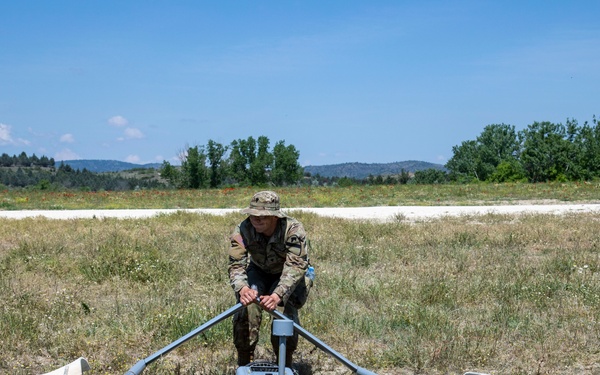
[233,265,300,354]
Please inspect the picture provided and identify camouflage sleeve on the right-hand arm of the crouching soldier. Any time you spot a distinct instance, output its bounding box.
[274,222,308,303]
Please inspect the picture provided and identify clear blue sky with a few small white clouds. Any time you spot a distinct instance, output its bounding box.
[0,0,600,165]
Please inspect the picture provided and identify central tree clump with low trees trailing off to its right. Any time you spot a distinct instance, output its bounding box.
[160,136,448,189]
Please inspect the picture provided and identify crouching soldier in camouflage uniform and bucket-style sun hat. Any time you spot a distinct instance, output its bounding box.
[228,191,312,367]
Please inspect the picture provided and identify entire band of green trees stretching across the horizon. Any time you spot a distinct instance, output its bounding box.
[0,116,600,190]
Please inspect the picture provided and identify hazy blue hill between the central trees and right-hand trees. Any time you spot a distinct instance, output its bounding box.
[304,160,446,179]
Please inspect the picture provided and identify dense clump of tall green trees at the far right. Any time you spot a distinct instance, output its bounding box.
[445,116,600,182]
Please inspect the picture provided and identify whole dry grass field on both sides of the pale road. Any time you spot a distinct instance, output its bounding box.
[0,184,600,375]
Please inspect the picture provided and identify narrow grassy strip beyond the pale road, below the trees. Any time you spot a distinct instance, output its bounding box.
[0,182,600,210]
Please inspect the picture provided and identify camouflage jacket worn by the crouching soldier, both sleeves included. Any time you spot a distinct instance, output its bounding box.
[228,217,309,303]
